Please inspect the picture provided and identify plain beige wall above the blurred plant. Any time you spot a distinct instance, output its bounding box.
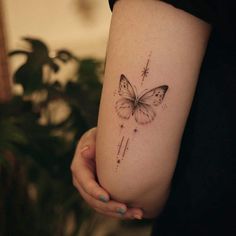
[2,0,111,58]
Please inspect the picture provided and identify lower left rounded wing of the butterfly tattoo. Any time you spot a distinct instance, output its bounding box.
[115,98,134,120]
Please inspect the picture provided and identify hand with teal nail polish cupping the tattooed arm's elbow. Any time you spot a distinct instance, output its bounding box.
[71,128,143,219]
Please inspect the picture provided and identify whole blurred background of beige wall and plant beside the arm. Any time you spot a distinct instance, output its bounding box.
[0,0,150,236]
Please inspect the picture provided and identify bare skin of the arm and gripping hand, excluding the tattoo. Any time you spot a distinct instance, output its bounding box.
[71,0,210,219]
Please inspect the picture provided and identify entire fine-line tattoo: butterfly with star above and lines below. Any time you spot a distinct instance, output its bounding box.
[115,54,169,168]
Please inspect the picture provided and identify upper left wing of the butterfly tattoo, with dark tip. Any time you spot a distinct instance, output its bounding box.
[118,74,136,101]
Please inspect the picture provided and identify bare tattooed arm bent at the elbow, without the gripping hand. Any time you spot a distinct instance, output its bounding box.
[96,0,210,217]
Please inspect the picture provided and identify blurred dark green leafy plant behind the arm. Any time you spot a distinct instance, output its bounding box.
[0,38,103,236]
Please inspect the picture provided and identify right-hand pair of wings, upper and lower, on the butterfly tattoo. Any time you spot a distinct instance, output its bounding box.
[134,85,168,125]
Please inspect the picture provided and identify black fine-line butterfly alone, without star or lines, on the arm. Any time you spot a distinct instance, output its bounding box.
[115,74,168,125]
